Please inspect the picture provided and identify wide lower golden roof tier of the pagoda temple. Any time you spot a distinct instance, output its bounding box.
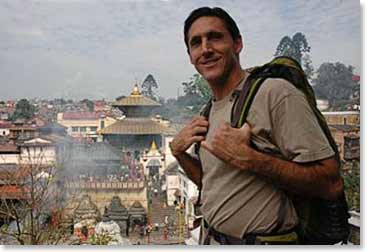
[101,118,175,135]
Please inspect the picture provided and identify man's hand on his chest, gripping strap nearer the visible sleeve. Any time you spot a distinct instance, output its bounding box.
[201,123,256,169]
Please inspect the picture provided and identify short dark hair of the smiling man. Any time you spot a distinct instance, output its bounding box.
[184,7,241,48]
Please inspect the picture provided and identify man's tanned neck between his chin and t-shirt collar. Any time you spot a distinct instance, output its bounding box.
[210,68,247,101]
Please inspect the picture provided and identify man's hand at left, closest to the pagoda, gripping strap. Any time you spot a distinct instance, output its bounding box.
[170,116,209,157]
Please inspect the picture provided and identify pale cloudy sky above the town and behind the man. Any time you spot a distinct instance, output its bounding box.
[0,0,362,100]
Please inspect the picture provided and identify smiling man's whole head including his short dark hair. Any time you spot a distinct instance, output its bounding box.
[184,7,243,85]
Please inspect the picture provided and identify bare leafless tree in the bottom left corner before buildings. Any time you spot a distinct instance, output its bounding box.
[0,147,69,245]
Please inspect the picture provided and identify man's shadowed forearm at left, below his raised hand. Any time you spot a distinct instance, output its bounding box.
[175,152,202,186]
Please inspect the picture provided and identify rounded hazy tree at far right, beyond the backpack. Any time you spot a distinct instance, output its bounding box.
[314,62,356,107]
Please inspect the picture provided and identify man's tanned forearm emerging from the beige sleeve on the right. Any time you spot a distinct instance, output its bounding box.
[233,151,343,199]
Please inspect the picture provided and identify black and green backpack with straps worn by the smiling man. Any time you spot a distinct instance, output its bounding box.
[195,56,350,245]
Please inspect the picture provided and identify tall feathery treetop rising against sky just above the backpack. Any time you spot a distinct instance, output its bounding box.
[274,32,311,65]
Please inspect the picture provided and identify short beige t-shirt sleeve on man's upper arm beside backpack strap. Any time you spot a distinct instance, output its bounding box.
[271,90,335,163]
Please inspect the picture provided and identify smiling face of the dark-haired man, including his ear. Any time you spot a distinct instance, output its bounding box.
[188,17,242,83]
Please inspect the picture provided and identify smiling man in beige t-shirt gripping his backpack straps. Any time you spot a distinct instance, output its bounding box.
[170,7,343,244]
